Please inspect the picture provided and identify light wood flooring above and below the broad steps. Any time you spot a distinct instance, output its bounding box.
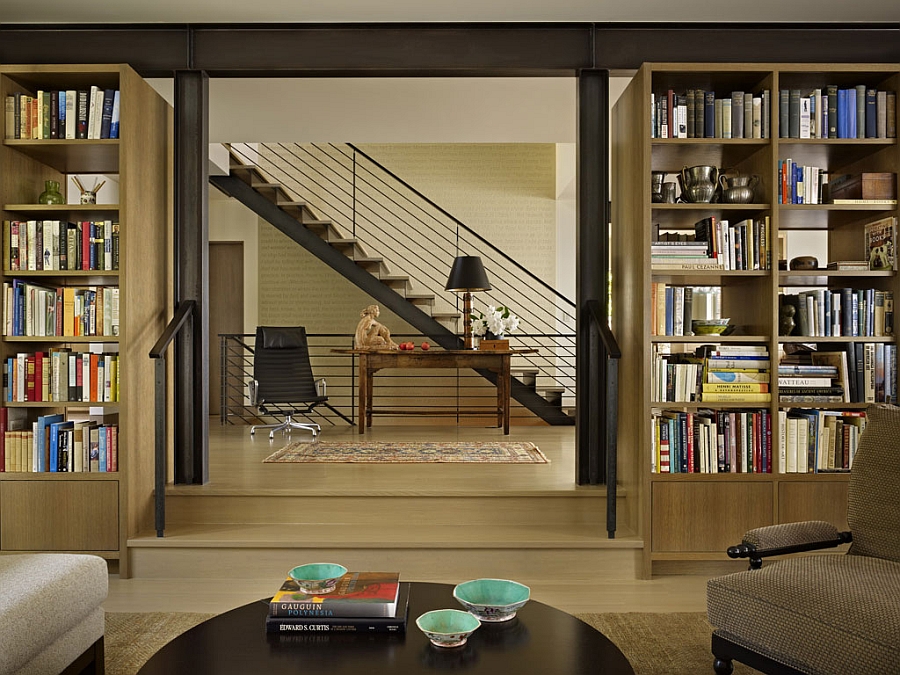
[104,418,708,613]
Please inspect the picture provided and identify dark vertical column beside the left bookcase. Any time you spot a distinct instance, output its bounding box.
[175,70,209,484]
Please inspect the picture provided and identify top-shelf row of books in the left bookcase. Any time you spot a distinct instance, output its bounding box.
[5,86,120,140]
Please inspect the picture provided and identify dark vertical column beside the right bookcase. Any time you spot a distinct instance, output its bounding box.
[575,69,609,485]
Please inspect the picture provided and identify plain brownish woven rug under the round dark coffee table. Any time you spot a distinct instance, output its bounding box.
[105,612,757,675]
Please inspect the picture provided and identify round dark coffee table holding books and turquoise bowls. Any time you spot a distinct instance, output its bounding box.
[140,582,634,675]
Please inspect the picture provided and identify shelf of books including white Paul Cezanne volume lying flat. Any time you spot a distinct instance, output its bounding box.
[650,216,772,270]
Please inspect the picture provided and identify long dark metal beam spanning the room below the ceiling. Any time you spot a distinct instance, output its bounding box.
[0,23,900,77]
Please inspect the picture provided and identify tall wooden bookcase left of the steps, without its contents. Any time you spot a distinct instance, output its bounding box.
[0,65,172,576]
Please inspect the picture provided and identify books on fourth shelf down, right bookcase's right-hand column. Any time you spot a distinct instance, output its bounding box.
[778,288,894,337]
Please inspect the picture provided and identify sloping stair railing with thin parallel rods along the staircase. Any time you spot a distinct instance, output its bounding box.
[232,143,575,404]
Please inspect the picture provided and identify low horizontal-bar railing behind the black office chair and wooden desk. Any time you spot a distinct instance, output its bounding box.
[219,333,574,426]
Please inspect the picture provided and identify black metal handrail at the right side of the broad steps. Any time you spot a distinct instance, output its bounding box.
[585,300,622,539]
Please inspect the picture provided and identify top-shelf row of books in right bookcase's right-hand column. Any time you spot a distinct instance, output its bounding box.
[778,84,897,138]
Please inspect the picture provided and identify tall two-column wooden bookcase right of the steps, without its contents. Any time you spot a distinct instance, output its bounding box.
[612,63,900,576]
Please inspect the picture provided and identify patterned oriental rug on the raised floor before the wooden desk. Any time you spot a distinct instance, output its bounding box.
[263,441,550,464]
